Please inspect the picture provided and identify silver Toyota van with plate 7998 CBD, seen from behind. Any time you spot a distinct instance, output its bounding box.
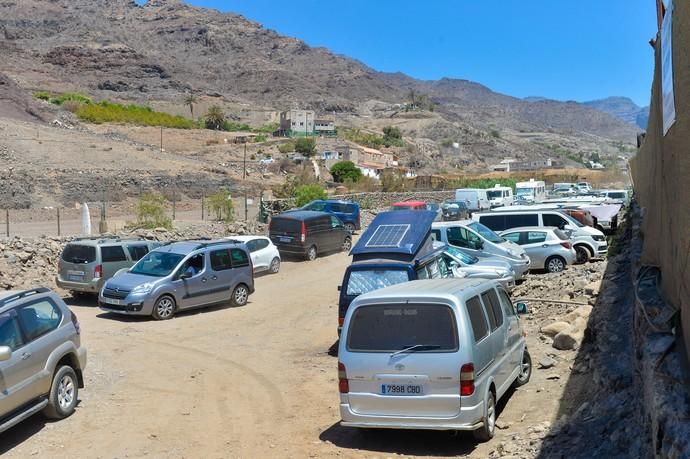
[338,279,532,441]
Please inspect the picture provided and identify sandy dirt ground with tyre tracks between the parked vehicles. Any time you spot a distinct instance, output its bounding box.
[0,254,584,458]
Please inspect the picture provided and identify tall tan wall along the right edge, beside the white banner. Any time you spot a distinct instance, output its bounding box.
[630,0,690,364]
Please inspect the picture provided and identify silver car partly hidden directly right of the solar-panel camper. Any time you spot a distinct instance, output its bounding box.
[443,246,515,291]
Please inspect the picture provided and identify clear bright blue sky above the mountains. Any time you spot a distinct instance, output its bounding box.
[142,0,656,105]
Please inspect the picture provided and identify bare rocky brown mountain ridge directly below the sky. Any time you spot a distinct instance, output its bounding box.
[0,0,636,142]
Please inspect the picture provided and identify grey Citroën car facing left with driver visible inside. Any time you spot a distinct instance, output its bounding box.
[98,240,254,320]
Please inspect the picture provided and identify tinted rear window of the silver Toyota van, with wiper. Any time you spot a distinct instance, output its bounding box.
[347,304,458,352]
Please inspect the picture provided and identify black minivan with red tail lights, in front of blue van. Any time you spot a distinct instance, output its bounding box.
[268,210,352,260]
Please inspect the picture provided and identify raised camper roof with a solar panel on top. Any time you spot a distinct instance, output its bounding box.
[350,210,437,261]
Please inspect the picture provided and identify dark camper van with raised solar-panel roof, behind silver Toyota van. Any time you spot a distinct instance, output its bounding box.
[338,210,446,330]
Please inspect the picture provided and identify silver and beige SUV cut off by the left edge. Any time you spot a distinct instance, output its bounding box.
[0,288,86,432]
